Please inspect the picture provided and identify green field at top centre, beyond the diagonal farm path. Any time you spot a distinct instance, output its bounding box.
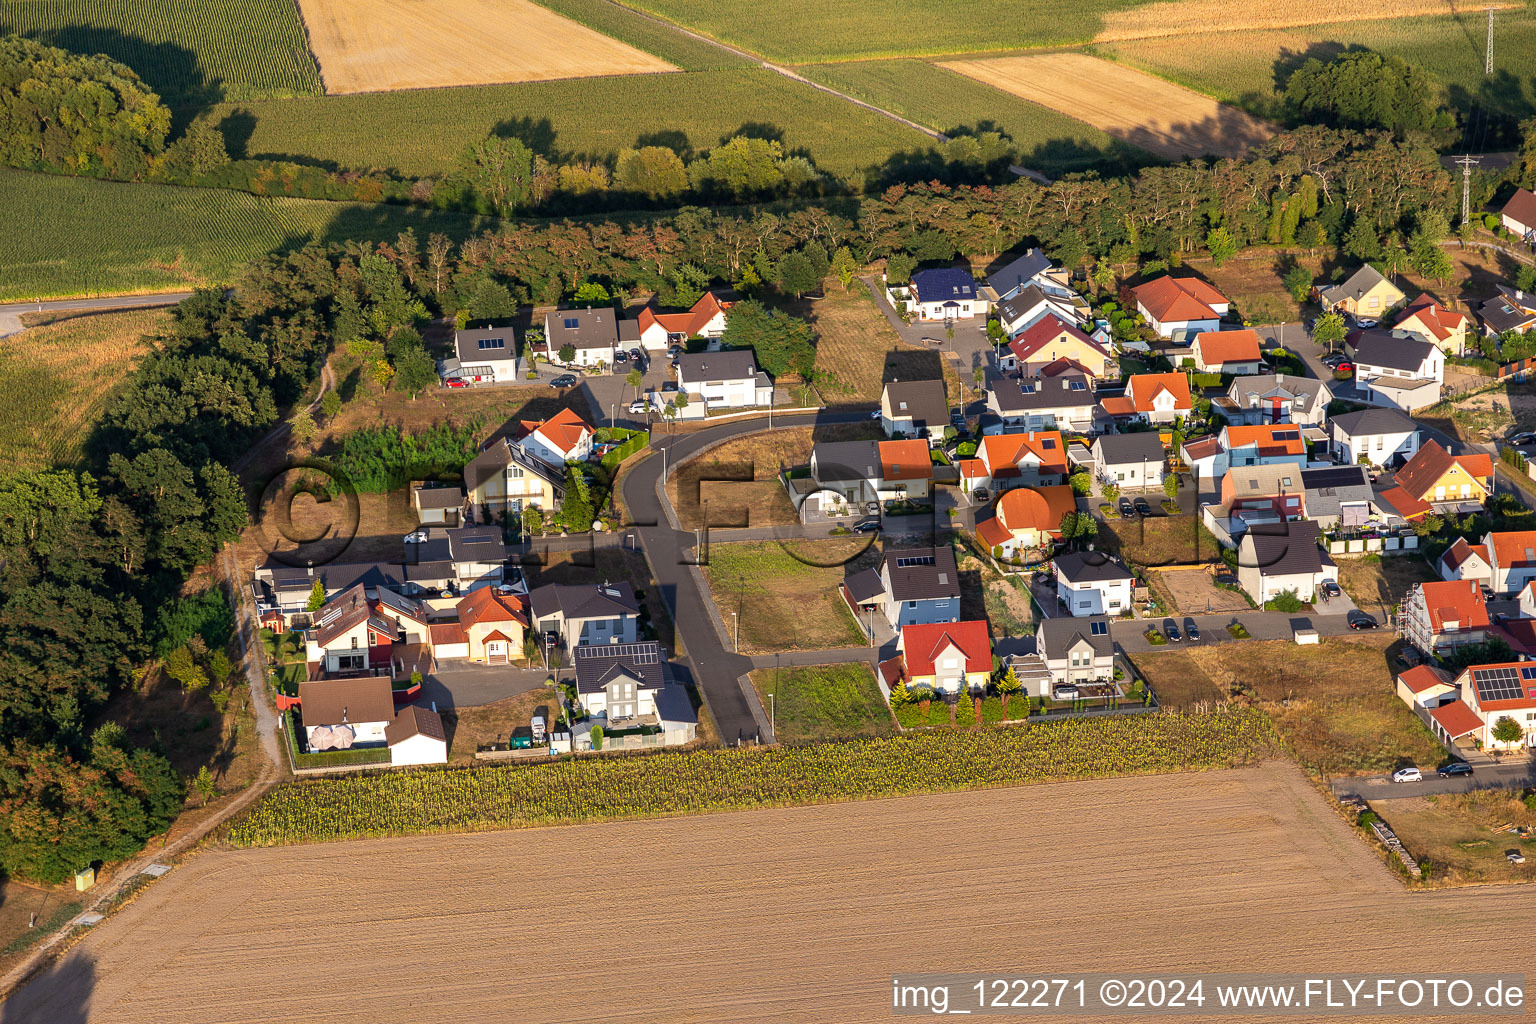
[617,0,1140,63]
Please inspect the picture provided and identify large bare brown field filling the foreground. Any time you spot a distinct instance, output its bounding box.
[0,765,1530,1024]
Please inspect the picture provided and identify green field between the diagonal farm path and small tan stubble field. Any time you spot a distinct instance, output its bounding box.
[799,58,1146,175]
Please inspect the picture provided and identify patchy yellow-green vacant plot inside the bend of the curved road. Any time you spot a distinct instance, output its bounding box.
[702,536,880,654]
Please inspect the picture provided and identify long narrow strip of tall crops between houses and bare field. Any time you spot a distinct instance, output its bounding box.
[229,708,1275,846]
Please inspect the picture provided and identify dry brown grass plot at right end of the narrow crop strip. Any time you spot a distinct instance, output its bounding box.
[1137,636,1444,775]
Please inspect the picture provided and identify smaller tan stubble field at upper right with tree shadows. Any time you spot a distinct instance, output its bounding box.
[943,54,1275,160]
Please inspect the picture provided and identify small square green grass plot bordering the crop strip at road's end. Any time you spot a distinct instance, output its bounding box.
[751,665,895,743]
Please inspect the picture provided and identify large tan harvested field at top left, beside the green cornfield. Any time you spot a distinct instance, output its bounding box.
[300,0,677,92]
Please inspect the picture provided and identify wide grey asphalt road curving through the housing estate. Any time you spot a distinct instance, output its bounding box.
[624,411,869,746]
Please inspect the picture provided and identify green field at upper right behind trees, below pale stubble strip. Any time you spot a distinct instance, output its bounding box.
[1095,8,1536,117]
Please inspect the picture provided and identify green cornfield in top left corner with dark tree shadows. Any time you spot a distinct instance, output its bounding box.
[0,0,321,106]
